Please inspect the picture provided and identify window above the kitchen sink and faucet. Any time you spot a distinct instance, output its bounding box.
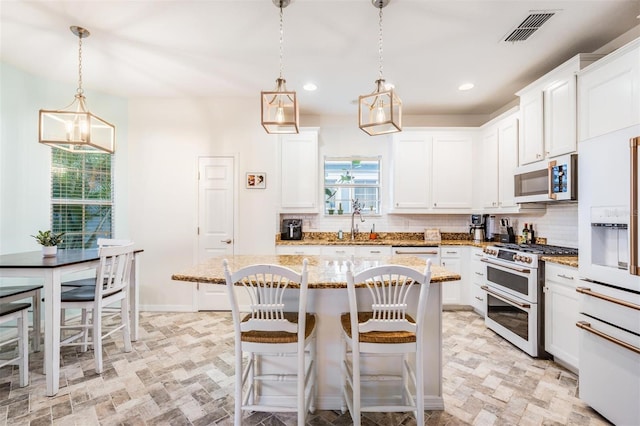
[324,157,380,215]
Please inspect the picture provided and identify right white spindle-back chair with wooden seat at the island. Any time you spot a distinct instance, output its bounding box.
[340,260,431,426]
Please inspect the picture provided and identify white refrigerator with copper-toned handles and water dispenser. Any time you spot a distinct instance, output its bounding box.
[576,126,640,426]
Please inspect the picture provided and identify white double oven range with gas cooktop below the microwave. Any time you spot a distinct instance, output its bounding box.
[482,243,578,358]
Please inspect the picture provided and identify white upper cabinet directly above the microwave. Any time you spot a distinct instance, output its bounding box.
[517,54,602,165]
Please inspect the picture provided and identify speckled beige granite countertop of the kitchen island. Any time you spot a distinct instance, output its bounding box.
[171,255,461,288]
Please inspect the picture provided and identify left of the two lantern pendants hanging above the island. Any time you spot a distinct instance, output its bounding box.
[260,0,299,134]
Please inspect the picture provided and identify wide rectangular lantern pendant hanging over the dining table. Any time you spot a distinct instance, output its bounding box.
[38,26,116,154]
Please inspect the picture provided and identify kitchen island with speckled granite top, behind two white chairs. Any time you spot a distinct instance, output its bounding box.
[171,255,460,410]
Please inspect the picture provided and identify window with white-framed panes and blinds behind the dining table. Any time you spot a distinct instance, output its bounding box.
[51,149,113,248]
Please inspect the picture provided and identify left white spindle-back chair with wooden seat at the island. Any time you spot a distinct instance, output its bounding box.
[223,259,316,426]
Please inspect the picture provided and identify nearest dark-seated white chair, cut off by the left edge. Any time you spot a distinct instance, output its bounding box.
[0,302,31,387]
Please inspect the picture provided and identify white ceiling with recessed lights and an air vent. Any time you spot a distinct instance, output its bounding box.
[0,0,640,115]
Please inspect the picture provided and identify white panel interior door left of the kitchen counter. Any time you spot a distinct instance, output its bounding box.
[197,157,235,311]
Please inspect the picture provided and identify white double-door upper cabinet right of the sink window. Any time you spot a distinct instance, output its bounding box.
[390,128,477,213]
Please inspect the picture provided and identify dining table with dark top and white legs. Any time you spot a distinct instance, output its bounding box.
[0,248,143,396]
